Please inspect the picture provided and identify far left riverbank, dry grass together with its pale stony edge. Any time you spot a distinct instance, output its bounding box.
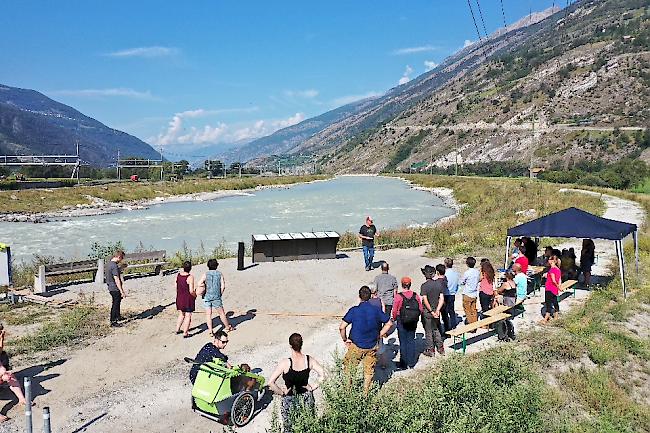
[0,176,330,223]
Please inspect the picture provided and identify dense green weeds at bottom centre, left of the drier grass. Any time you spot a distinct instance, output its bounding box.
[272,348,544,433]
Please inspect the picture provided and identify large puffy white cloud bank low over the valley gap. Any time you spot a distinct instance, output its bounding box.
[149,109,305,147]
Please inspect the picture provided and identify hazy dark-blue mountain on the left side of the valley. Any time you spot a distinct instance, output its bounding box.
[0,85,159,166]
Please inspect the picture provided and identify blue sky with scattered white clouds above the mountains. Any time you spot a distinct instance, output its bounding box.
[0,0,555,159]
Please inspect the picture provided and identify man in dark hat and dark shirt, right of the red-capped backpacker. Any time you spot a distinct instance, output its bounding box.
[420,264,447,356]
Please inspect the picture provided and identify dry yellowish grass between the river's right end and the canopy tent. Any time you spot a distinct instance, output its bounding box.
[339,175,604,257]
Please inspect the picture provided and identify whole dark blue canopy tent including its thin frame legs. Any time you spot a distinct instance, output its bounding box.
[506,207,639,297]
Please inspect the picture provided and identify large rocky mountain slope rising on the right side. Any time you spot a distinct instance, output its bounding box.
[249,0,650,172]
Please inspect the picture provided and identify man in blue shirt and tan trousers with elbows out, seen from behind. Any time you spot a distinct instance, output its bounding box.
[339,286,393,392]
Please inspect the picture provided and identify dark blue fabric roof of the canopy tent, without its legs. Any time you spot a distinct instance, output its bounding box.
[508,207,636,240]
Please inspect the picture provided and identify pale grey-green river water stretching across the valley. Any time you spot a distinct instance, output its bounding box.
[0,176,453,260]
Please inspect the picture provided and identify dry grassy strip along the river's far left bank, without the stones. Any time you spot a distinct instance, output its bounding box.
[0,176,327,213]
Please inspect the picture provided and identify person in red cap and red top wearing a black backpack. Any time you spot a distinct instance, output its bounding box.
[392,277,422,370]
